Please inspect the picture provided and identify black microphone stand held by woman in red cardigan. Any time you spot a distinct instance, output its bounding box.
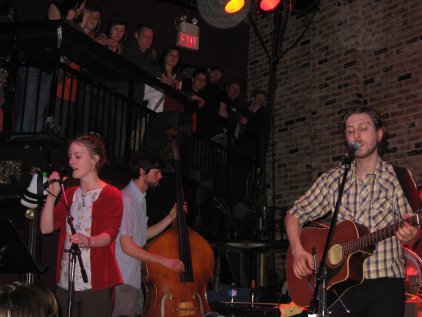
[60,182,88,317]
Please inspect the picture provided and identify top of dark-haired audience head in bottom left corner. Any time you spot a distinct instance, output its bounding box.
[0,282,59,317]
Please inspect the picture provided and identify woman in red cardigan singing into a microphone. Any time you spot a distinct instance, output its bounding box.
[40,134,123,317]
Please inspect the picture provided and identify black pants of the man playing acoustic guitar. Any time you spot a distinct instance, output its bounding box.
[330,278,405,317]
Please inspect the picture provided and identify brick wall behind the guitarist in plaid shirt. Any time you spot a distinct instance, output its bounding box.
[248,0,422,210]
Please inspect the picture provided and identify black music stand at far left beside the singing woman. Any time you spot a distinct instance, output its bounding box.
[0,219,47,273]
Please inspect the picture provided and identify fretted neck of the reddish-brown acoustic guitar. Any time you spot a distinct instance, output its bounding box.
[343,213,421,254]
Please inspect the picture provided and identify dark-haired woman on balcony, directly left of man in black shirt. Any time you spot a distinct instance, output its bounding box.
[96,15,127,55]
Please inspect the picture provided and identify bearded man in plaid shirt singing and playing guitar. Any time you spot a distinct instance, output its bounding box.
[285,106,419,317]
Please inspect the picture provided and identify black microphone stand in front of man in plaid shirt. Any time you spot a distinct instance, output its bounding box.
[308,155,354,317]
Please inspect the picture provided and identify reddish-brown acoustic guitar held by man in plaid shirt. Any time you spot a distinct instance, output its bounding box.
[286,213,421,307]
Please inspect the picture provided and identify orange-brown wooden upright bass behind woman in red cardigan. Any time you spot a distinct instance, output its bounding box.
[143,129,214,317]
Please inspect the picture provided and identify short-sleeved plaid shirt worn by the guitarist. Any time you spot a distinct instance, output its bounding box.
[288,159,413,279]
